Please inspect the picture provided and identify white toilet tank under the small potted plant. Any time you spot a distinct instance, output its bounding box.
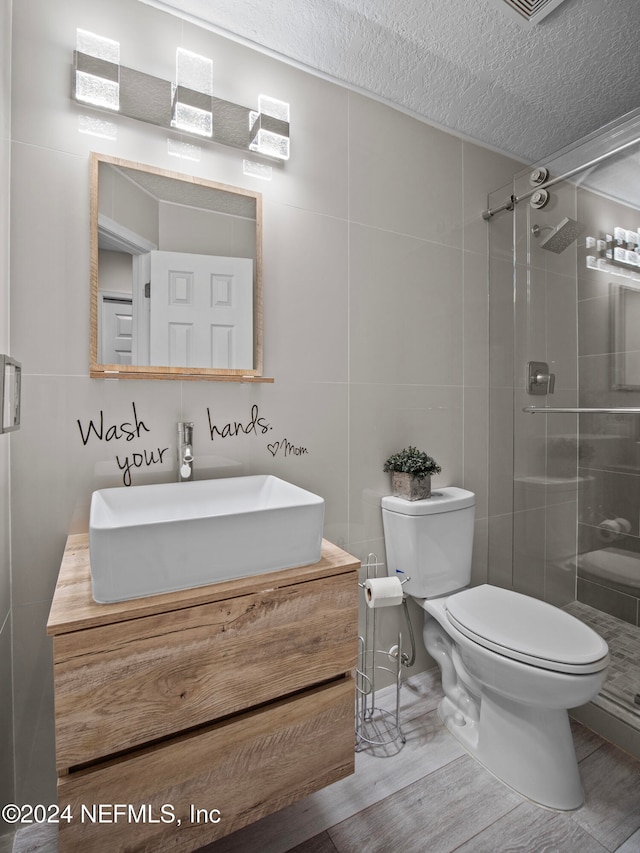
[382,486,475,598]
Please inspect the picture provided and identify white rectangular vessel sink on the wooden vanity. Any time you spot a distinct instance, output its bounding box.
[89,475,324,603]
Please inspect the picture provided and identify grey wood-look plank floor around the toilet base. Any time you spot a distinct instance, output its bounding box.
[8,671,640,853]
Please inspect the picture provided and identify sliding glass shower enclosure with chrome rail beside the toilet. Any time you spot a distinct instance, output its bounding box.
[489,106,640,728]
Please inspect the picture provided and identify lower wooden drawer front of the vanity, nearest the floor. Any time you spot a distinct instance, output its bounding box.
[58,676,354,853]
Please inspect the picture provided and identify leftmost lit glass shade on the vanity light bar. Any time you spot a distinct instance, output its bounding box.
[75,29,120,110]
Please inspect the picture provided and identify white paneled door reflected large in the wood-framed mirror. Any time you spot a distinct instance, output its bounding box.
[149,251,253,369]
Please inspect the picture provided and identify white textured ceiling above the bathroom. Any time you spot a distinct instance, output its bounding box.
[143,0,640,162]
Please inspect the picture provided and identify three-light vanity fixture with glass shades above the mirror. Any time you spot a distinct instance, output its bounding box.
[71,31,290,161]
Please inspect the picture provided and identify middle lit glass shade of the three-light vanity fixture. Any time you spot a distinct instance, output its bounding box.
[171,47,213,136]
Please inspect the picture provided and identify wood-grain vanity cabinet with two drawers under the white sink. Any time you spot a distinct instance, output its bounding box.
[47,535,359,853]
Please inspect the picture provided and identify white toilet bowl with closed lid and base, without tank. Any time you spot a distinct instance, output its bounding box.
[419,585,609,811]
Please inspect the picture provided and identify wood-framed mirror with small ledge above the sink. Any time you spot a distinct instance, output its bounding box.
[90,153,273,382]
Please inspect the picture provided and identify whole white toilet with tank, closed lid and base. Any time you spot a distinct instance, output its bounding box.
[382,487,609,811]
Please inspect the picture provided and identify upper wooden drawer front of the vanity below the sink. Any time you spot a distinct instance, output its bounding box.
[54,572,358,772]
